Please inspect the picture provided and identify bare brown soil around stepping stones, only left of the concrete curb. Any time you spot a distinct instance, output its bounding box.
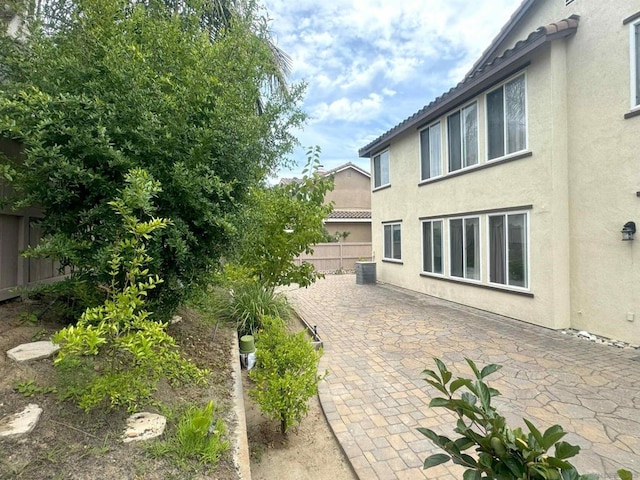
[0,301,239,480]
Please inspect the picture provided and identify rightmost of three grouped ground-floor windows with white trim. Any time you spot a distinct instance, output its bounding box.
[489,213,529,288]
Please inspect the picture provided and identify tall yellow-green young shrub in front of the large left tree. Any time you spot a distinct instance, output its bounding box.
[54,169,206,411]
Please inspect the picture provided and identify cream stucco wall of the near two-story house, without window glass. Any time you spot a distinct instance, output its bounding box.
[361,0,640,343]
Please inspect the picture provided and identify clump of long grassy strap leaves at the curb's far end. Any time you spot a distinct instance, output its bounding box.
[208,279,291,336]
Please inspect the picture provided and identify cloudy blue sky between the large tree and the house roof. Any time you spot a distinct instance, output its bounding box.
[263,0,521,177]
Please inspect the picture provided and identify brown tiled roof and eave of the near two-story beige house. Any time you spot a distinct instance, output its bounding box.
[358,14,580,157]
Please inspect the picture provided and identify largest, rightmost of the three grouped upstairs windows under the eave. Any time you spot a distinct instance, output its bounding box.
[487,74,527,160]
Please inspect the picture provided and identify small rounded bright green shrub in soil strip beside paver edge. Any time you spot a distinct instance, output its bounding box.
[249,317,324,434]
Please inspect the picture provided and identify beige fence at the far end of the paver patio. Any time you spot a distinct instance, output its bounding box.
[296,242,371,272]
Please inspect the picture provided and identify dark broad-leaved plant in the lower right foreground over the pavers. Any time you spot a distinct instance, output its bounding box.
[418,358,628,480]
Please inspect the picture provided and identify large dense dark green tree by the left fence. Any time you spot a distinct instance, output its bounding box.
[0,0,305,314]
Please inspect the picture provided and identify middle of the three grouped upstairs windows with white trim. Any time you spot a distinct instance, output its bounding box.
[447,102,478,172]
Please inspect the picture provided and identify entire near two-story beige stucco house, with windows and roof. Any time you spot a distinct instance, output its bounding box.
[360,0,640,344]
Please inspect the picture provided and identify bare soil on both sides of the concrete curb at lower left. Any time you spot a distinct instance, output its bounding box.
[0,301,357,480]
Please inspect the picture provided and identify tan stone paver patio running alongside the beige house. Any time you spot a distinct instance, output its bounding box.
[286,275,640,480]
